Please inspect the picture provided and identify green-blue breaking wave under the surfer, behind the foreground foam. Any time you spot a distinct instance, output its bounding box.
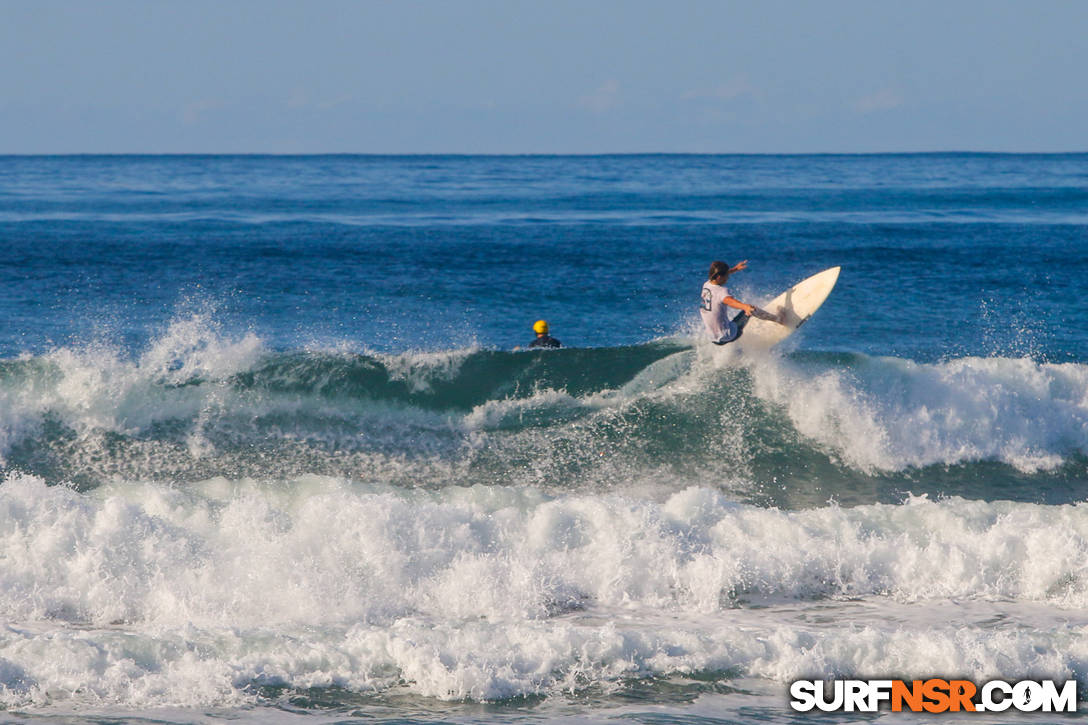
[0,341,1088,508]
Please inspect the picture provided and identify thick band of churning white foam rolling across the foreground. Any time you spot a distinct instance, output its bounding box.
[6,476,1088,708]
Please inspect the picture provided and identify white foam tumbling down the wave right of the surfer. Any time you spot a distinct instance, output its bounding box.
[751,357,1088,472]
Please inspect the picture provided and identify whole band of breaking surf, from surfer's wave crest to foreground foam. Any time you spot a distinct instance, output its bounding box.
[0,318,1088,709]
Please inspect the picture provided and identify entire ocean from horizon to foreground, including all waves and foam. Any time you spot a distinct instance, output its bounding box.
[0,153,1088,722]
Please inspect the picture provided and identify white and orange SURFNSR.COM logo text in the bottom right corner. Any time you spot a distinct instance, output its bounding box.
[790,678,1077,713]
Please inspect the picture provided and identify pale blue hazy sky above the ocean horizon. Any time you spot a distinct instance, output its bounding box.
[0,0,1088,153]
